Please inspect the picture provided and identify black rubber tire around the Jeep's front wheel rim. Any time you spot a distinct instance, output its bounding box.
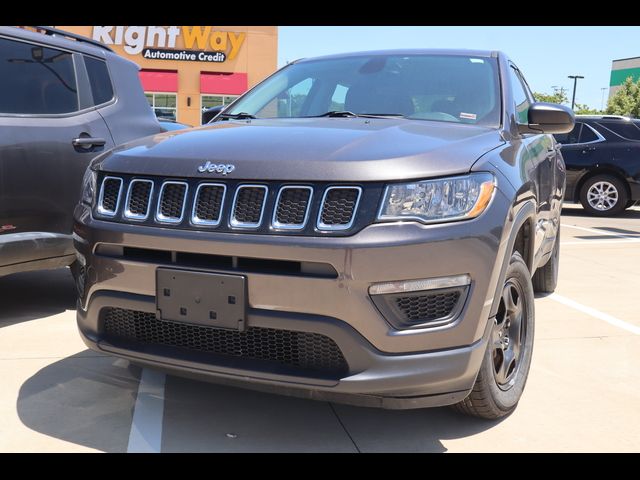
[452,252,535,419]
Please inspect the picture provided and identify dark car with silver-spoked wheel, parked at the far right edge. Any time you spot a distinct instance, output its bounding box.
[555,115,640,216]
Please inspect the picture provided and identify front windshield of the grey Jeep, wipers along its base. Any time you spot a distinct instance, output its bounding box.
[224,54,500,127]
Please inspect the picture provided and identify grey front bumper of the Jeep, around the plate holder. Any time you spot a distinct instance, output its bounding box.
[74,186,509,408]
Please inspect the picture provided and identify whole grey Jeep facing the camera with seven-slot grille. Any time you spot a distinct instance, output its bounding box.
[75,50,573,418]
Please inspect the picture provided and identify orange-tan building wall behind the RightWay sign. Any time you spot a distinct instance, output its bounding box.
[57,26,278,125]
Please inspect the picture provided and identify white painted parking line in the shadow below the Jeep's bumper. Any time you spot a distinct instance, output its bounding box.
[127,368,165,453]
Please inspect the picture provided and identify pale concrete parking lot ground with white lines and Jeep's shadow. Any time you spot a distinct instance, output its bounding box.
[0,205,640,452]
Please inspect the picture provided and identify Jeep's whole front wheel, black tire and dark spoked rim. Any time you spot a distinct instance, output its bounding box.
[453,252,535,419]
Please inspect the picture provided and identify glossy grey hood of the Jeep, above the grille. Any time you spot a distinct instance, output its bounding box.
[96,117,504,182]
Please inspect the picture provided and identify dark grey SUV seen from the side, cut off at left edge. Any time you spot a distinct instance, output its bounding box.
[0,27,162,276]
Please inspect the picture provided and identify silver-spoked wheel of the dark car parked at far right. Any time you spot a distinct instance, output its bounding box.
[580,175,629,217]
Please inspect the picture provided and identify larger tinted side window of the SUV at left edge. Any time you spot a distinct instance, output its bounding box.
[0,38,78,114]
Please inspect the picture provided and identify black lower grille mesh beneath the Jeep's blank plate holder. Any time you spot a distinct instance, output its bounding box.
[103,308,348,376]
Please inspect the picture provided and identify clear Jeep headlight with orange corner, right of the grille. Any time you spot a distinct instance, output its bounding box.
[378,173,495,223]
